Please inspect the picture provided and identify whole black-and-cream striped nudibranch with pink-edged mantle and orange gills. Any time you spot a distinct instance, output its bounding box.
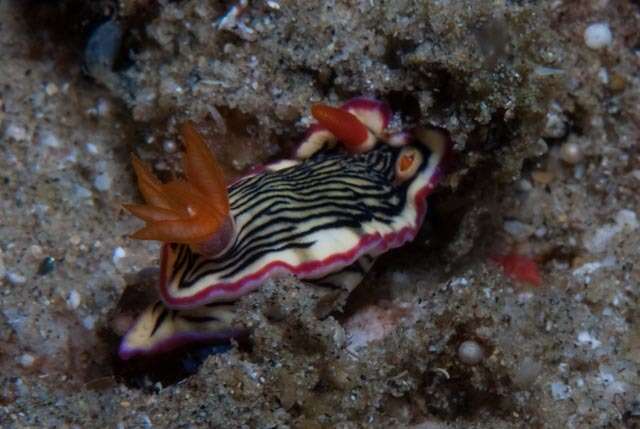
[119,98,448,359]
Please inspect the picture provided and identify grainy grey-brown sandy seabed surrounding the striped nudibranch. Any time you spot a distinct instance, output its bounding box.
[0,0,640,429]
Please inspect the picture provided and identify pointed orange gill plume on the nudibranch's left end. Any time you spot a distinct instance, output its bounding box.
[124,122,234,255]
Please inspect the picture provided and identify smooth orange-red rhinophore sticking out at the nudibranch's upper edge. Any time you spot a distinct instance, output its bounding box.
[311,104,369,149]
